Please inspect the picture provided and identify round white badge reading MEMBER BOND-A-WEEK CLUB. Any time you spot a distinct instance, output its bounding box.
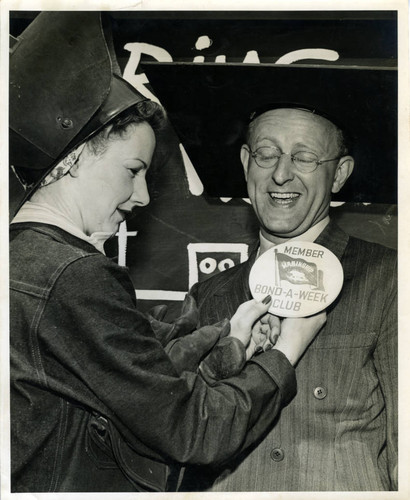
[249,241,343,318]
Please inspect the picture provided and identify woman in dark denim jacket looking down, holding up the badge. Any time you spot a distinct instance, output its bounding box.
[10,13,324,492]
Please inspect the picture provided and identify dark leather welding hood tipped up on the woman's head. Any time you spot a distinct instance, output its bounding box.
[9,11,145,191]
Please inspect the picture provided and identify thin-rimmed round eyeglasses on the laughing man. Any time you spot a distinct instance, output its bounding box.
[249,146,340,174]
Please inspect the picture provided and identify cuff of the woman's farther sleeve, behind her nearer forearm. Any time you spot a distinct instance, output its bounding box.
[199,337,246,384]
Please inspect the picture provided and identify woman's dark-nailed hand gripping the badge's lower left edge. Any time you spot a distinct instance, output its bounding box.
[229,295,272,359]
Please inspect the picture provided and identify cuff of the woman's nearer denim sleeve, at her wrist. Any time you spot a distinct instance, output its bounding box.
[249,349,297,404]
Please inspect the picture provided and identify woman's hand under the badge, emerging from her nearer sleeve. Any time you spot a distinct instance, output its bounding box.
[274,312,326,365]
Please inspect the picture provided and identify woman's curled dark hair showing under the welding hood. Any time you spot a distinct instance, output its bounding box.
[87,99,166,156]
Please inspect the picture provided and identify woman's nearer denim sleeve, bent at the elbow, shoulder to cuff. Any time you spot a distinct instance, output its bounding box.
[38,255,296,464]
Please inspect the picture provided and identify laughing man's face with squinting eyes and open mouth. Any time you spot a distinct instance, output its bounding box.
[241,109,353,242]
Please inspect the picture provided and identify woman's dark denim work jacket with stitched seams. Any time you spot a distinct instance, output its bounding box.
[10,223,296,492]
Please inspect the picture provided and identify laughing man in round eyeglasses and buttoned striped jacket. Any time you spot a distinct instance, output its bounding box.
[182,103,397,491]
